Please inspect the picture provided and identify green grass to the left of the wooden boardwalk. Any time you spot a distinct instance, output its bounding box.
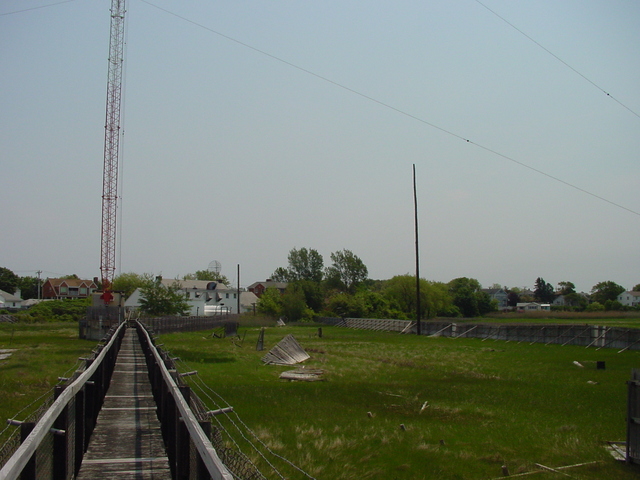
[0,322,96,444]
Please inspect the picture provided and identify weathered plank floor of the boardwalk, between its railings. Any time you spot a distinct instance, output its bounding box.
[77,329,171,480]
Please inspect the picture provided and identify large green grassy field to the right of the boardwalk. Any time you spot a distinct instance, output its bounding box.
[160,326,640,480]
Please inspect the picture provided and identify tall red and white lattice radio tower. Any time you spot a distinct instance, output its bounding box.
[100,0,125,305]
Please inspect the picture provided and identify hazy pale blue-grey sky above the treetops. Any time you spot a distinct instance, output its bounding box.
[0,0,640,292]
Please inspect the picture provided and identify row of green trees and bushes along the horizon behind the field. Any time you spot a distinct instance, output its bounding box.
[0,256,640,320]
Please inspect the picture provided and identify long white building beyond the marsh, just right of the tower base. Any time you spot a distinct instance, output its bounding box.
[124,278,258,317]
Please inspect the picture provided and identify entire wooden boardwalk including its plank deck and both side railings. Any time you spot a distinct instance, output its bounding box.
[0,322,233,480]
